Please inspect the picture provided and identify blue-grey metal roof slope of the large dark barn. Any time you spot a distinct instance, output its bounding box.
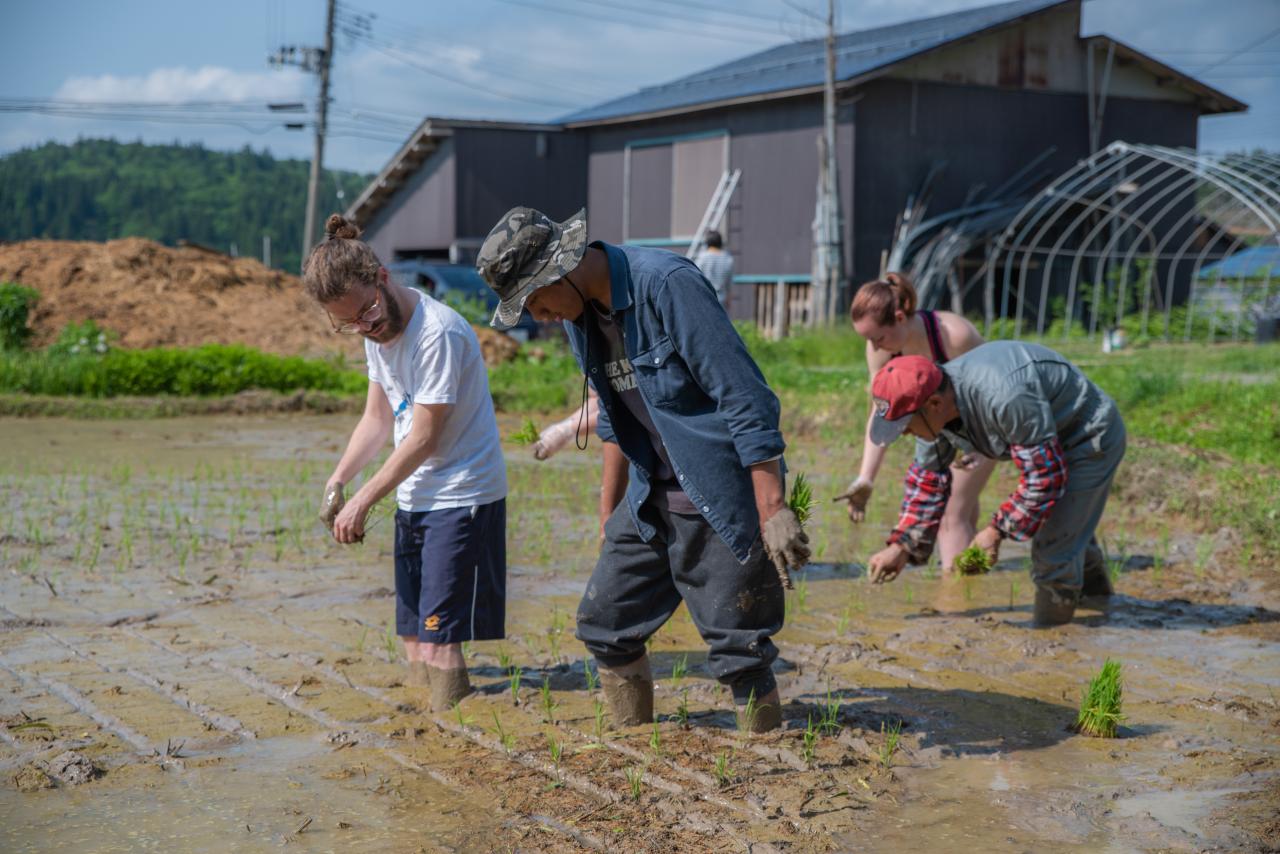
[559,0,1076,124]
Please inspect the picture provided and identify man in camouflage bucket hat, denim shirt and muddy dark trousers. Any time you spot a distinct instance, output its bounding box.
[476,207,809,731]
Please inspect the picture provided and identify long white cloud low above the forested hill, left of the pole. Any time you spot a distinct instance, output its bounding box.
[54,65,314,102]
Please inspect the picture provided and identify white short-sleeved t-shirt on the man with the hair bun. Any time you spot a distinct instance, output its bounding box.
[365,293,507,511]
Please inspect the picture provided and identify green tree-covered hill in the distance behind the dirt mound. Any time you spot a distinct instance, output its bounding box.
[0,140,370,273]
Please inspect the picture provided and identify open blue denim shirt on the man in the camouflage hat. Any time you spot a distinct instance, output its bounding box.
[564,242,786,563]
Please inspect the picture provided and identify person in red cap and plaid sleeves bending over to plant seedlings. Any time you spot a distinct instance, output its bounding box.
[868,341,1125,626]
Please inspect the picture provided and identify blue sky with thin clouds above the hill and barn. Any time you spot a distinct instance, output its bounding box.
[0,0,1280,172]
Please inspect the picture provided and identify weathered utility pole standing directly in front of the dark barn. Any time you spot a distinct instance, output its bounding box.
[810,0,844,325]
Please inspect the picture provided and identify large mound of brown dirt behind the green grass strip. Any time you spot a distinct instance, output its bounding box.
[0,237,517,365]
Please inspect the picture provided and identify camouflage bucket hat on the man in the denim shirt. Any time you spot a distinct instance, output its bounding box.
[476,207,586,329]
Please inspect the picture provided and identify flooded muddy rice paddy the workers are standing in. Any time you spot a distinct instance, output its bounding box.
[0,417,1280,851]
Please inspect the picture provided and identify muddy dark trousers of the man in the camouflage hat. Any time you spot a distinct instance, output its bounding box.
[577,502,783,704]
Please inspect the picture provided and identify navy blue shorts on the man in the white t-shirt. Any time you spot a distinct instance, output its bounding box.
[396,498,507,644]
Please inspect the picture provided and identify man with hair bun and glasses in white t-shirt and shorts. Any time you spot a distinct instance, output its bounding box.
[303,214,507,712]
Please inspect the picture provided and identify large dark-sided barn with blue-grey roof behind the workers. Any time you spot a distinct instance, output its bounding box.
[348,0,1245,318]
